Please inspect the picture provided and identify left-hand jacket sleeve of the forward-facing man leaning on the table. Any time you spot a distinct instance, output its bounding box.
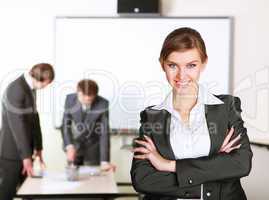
[61,96,74,147]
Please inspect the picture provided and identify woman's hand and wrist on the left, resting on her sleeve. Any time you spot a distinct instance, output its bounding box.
[133,135,176,172]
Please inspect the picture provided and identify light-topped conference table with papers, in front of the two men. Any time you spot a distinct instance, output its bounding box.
[16,167,138,200]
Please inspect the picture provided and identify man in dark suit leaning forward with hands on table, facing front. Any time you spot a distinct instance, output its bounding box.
[62,79,115,171]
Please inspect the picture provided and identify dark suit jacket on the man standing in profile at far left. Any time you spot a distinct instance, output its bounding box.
[0,75,42,160]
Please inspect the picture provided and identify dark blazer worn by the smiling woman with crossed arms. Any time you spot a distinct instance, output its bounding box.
[131,95,252,200]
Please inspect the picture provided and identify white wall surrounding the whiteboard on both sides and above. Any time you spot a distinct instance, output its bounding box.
[0,0,269,198]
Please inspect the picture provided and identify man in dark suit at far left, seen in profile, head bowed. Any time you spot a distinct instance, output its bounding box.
[0,63,54,200]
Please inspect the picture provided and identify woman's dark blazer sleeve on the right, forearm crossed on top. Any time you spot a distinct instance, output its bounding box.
[176,96,252,187]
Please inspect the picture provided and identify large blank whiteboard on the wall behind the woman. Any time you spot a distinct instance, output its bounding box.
[55,17,232,129]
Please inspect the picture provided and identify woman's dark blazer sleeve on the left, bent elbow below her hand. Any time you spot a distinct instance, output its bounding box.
[130,112,201,198]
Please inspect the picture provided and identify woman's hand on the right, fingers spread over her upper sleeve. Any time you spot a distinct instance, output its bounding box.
[219,127,241,153]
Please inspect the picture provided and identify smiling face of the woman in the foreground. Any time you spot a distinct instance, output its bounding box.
[162,48,206,91]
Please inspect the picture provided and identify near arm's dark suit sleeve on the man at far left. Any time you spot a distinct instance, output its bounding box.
[4,87,33,160]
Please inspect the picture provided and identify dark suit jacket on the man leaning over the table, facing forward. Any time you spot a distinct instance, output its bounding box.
[62,93,110,164]
